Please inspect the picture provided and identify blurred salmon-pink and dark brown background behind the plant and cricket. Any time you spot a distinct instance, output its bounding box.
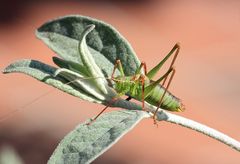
[0,0,240,164]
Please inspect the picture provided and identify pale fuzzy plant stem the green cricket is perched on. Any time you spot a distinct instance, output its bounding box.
[114,99,240,152]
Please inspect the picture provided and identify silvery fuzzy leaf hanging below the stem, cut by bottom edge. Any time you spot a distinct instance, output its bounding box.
[48,110,149,164]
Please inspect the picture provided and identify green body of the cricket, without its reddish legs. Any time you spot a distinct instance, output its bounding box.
[114,76,184,111]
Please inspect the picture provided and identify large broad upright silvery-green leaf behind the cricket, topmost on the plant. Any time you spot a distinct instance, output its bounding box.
[36,15,140,76]
